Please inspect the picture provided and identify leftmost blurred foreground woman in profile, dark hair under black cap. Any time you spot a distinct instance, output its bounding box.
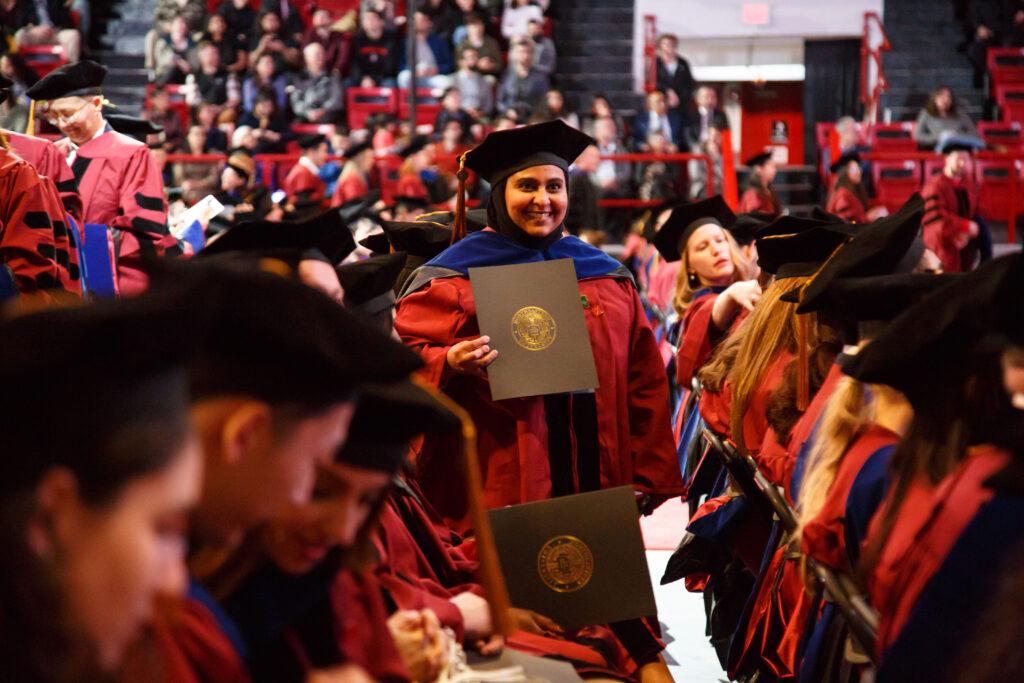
[0,294,202,682]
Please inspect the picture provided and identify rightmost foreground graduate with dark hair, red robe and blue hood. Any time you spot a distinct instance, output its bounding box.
[839,255,1024,681]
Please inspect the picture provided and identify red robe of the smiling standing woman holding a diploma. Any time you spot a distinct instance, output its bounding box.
[395,276,683,530]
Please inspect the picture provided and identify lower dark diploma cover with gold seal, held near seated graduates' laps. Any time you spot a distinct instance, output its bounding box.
[489,486,657,629]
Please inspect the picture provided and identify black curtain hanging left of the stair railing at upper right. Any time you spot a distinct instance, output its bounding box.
[804,38,864,165]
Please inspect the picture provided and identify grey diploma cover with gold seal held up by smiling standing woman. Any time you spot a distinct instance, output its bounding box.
[469,258,597,400]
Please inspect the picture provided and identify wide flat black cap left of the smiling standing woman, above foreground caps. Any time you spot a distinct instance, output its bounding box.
[200,209,355,264]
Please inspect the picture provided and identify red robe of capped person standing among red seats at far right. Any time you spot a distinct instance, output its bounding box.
[921,173,978,272]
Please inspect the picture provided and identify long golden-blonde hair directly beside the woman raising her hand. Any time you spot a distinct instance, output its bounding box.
[699,276,816,453]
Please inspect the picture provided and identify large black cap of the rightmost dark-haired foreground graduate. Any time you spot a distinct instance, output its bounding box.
[844,253,1024,403]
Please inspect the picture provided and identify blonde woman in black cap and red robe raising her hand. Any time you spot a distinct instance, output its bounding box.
[654,195,761,387]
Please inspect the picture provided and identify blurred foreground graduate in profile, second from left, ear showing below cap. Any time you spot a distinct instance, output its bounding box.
[128,259,420,680]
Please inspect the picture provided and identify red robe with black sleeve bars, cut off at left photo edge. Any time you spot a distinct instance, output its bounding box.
[0,148,63,296]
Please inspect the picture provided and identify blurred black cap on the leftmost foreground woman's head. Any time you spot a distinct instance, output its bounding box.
[0,295,195,496]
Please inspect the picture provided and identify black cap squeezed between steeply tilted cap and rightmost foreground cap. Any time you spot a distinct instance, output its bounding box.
[811,272,959,335]
